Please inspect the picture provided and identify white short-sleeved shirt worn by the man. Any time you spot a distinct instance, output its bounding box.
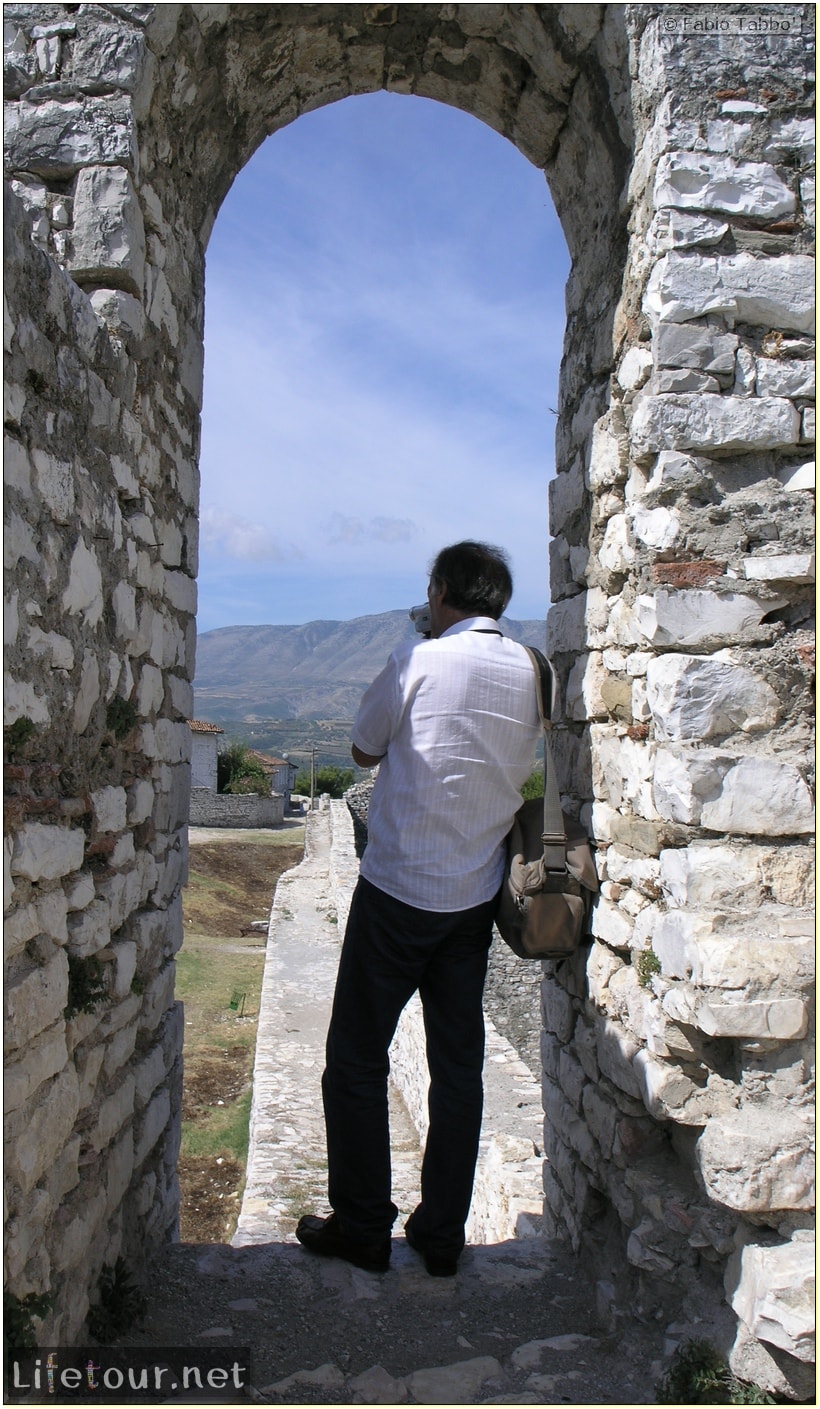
[352,617,540,912]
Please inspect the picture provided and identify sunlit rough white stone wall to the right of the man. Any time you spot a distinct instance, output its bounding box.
[542,6,814,1392]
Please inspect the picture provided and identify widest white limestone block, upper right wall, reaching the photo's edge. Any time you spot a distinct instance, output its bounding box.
[644,252,814,333]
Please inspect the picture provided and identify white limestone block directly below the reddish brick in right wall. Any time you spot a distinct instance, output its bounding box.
[634,588,785,647]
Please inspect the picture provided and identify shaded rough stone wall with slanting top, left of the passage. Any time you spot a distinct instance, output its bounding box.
[4,187,188,1344]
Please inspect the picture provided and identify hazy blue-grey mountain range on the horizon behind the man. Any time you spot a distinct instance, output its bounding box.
[193,612,545,724]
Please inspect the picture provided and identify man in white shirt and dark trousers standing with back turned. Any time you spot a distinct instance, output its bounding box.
[296,541,540,1277]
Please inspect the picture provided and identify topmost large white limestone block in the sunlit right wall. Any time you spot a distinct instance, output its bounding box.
[654,152,795,220]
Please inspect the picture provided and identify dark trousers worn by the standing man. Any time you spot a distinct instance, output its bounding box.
[321,878,496,1254]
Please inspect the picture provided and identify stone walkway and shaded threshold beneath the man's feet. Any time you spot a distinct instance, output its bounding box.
[128,813,676,1405]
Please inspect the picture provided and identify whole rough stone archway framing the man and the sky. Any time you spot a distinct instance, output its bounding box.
[6,4,813,1385]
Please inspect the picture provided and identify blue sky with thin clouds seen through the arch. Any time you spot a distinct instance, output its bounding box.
[197,93,569,631]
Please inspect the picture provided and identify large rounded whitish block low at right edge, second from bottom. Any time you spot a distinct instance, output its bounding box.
[695,1105,814,1213]
